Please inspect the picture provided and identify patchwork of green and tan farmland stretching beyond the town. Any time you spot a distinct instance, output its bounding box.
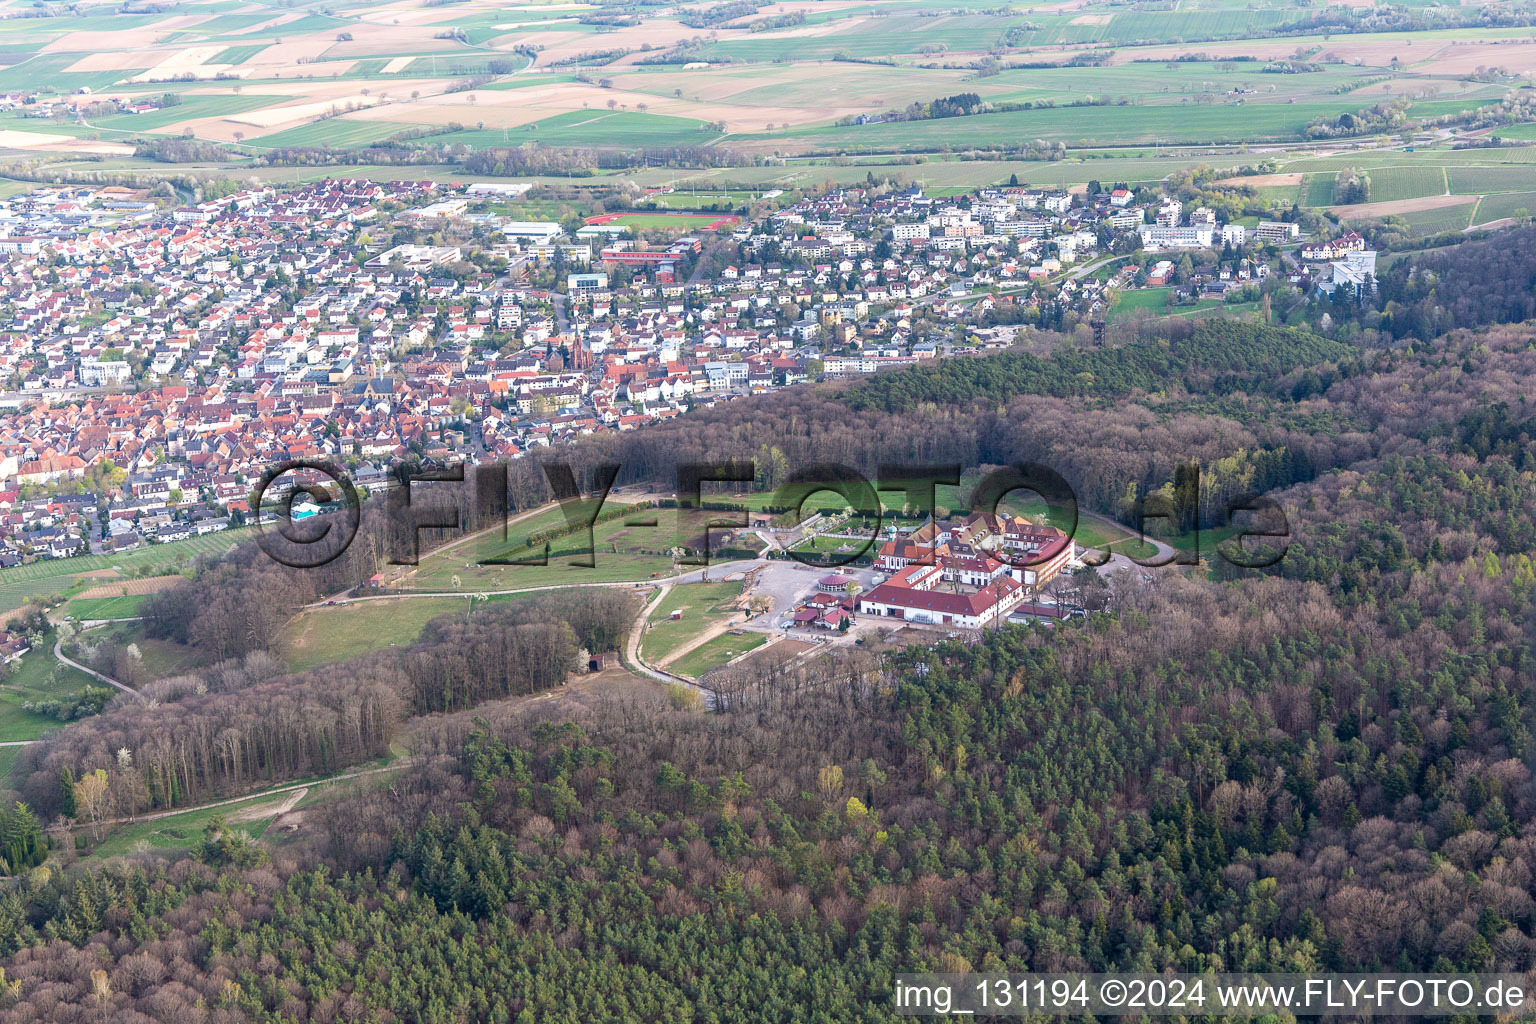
[0,0,1536,168]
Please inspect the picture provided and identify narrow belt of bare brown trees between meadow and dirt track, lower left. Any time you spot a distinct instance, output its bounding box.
[12,585,637,835]
